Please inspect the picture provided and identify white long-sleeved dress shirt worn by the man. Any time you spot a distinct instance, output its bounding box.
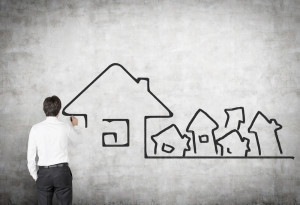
[27,117,73,180]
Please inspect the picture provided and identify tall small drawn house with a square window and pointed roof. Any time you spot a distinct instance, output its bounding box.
[186,109,219,156]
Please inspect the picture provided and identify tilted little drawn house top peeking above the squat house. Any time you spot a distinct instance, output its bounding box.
[224,107,245,130]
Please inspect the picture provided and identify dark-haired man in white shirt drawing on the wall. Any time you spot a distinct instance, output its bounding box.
[27,96,78,205]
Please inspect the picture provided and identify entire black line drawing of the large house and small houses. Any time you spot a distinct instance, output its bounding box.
[62,63,294,159]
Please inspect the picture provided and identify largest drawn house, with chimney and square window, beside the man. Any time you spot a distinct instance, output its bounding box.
[62,63,173,150]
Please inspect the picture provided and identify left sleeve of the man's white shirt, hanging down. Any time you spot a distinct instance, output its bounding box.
[27,128,37,180]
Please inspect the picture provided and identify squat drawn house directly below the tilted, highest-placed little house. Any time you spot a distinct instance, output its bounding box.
[217,130,251,157]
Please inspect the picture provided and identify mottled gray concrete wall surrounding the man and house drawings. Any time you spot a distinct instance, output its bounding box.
[0,0,300,204]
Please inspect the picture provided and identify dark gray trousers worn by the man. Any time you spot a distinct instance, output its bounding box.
[36,166,72,205]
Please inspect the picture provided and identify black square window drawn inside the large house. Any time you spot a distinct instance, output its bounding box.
[102,119,130,147]
